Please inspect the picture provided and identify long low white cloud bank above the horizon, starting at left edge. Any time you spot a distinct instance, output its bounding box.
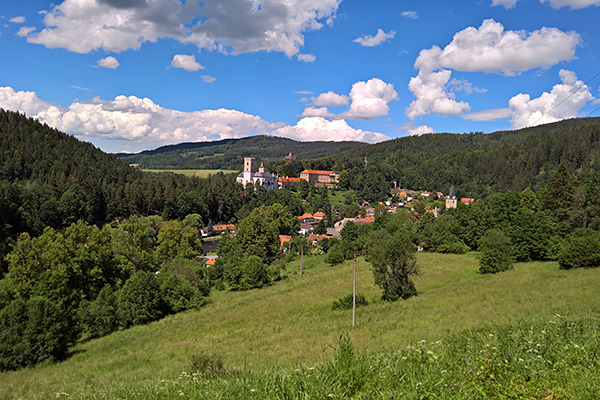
[0,87,388,150]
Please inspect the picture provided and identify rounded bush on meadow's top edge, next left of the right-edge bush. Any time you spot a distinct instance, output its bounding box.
[479,229,513,274]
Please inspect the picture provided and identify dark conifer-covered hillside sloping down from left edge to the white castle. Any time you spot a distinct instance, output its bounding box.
[0,109,243,271]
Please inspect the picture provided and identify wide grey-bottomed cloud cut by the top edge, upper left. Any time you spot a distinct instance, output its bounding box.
[23,0,341,57]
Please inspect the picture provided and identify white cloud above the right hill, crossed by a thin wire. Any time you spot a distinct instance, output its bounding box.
[508,69,594,129]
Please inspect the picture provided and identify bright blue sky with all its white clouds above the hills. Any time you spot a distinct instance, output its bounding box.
[0,0,600,153]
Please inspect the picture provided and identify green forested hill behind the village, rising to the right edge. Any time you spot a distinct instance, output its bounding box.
[296,118,600,201]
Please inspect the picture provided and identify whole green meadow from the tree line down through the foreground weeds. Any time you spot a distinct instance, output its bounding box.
[0,253,600,399]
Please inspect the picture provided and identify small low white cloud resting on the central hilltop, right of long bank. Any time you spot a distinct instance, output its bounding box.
[273,117,390,143]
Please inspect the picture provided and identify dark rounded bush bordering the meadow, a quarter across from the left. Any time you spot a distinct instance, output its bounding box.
[117,271,168,328]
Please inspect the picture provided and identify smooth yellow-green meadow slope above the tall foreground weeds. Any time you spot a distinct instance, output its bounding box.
[0,254,600,398]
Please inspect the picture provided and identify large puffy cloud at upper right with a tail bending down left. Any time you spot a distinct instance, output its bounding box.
[406,19,581,119]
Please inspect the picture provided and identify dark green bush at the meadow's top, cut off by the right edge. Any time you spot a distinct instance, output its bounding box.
[558,229,600,269]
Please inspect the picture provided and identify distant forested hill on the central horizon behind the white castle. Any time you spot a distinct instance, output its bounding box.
[117,136,365,170]
